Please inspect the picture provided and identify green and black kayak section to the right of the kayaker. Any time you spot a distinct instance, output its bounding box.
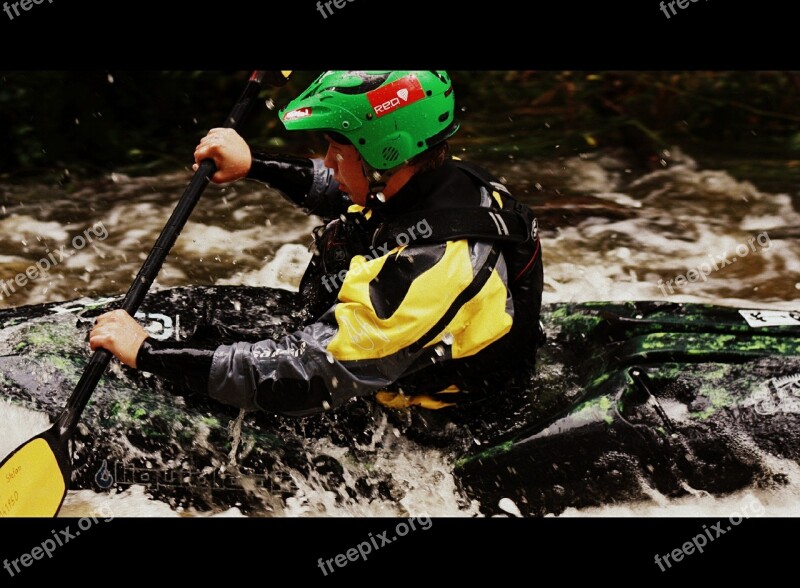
[455,302,800,515]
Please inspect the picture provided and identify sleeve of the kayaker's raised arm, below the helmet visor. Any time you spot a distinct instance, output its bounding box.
[247,151,352,219]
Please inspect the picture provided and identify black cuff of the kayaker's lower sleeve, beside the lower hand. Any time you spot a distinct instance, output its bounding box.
[136,338,215,395]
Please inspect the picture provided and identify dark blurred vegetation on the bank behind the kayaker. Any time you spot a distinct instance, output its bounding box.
[0,70,800,180]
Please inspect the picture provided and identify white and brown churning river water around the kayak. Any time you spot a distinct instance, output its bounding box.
[0,150,800,517]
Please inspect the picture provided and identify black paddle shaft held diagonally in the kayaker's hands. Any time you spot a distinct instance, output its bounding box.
[55,71,287,437]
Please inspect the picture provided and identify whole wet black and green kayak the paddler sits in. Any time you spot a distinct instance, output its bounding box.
[0,286,800,517]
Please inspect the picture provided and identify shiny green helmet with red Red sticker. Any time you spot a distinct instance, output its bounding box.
[280,71,458,170]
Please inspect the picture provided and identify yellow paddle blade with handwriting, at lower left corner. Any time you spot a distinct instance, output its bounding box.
[0,437,67,517]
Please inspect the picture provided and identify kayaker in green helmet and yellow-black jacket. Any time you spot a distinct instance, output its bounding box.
[90,71,543,416]
